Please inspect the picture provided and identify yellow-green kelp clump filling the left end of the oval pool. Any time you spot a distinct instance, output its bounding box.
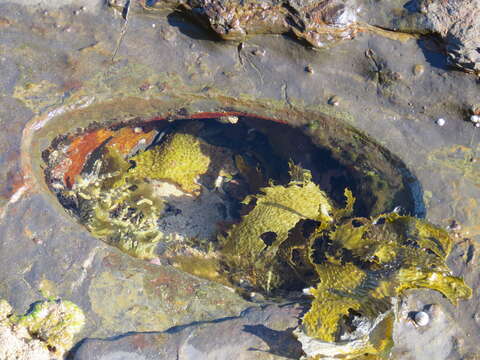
[63,122,240,259]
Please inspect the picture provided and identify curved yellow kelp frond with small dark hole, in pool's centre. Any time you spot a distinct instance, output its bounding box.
[220,165,332,293]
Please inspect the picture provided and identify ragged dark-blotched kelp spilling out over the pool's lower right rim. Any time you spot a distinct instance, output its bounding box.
[301,213,472,356]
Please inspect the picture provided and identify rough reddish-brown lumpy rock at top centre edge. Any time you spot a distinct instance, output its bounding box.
[148,0,357,47]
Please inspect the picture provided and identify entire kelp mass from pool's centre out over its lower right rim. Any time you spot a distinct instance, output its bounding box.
[221,168,472,358]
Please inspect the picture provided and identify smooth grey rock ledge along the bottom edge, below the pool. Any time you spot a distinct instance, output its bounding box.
[73,305,302,360]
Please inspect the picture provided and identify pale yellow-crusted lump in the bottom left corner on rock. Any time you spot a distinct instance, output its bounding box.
[0,299,85,360]
